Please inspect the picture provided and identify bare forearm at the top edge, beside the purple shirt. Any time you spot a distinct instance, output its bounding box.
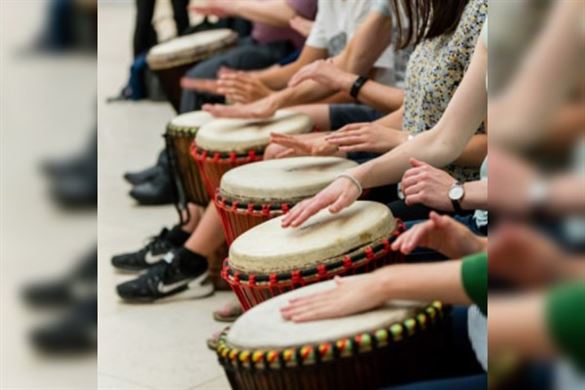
[232,0,296,27]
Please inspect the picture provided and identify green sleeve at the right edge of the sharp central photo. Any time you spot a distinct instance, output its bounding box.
[461,252,488,316]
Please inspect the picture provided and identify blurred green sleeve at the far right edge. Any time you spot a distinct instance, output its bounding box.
[546,282,585,370]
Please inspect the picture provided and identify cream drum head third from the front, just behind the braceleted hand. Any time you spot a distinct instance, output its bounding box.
[221,157,357,202]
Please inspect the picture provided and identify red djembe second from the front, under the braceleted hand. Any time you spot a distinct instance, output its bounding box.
[222,201,404,310]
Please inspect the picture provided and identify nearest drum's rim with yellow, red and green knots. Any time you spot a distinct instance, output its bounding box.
[216,300,442,370]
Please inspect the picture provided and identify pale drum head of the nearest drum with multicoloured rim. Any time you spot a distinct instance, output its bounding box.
[227,275,426,350]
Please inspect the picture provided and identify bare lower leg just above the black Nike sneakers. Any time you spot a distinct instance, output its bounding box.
[185,203,225,257]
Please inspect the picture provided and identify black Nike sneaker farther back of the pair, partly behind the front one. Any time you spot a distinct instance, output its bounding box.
[112,228,182,271]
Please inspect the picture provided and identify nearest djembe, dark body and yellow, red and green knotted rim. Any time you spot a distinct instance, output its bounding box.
[216,276,448,390]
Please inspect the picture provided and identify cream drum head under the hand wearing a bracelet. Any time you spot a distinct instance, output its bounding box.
[229,201,396,273]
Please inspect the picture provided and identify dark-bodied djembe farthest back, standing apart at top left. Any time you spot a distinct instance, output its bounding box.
[146,28,238,112]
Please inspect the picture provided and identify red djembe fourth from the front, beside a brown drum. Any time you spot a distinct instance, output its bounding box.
[192,110,313,198]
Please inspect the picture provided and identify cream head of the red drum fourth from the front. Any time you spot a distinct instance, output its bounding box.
[197,110,313,153]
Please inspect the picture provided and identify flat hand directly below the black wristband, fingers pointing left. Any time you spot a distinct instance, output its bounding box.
[325,122,408,153]
